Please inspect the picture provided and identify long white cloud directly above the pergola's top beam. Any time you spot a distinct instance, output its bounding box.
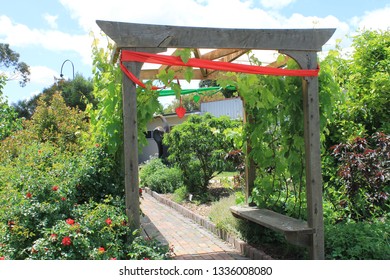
[54,0,350,63]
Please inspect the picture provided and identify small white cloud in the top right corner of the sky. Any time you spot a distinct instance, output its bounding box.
[351,6,390,30]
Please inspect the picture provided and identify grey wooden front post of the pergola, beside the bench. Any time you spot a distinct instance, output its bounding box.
[284,51,325,260]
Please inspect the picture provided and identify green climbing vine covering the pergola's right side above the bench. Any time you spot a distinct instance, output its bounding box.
[219,56,334,217]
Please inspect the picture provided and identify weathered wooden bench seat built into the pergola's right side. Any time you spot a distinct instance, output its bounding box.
[230,206,315,247]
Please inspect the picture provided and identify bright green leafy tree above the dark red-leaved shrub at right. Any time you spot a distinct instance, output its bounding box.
[321,30,390,142]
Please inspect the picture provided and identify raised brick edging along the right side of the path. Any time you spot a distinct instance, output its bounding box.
[144,188,272,260]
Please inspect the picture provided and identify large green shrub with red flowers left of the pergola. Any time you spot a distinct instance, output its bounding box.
[0,142,168,260]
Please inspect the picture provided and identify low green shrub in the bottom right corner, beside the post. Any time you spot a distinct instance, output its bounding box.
[325,222,390,260]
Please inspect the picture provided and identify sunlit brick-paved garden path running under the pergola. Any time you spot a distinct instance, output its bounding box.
[141,193,247,260]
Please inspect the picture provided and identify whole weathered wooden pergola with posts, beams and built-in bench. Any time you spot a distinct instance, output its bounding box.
[97,20,335,259]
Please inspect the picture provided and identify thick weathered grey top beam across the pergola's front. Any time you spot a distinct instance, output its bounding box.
[96,20,335,51]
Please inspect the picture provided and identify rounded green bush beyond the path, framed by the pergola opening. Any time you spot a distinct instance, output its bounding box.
[164,114,240,195]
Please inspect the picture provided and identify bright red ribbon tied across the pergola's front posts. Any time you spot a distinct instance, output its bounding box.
[120,50,319,90]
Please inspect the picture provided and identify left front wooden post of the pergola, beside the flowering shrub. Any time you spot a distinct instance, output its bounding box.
[122,62,142,229]
